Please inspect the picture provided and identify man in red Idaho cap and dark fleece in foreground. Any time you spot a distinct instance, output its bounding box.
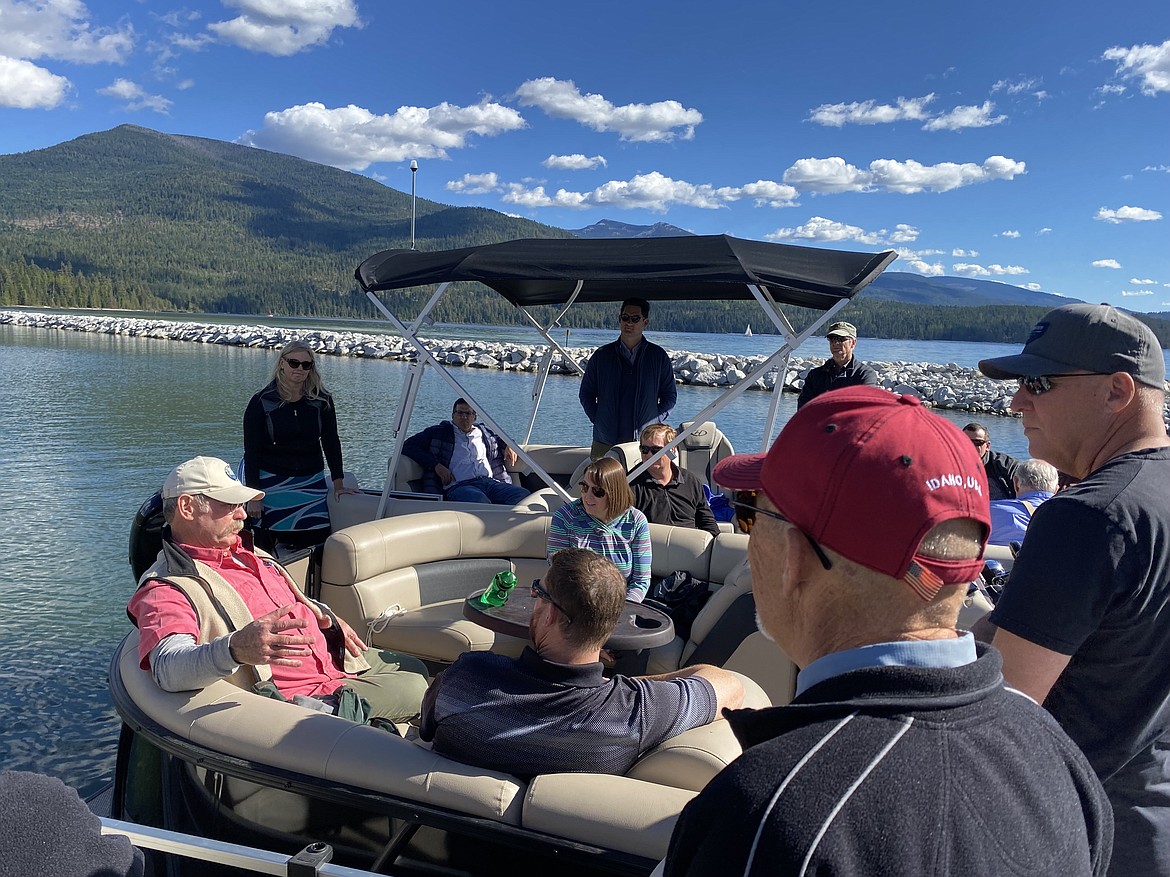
[665,387,1112,877]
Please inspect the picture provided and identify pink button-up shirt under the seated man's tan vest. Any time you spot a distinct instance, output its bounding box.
[129,538,352,698]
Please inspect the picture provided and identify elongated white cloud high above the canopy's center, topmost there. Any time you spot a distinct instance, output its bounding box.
[516,76,703,143]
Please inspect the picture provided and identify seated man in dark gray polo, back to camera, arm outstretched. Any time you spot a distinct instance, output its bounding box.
[419,548,743,776]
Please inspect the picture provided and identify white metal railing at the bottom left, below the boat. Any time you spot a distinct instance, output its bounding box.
[102,816,374,877]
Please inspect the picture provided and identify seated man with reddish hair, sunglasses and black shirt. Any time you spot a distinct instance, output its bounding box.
[629,423,720,536]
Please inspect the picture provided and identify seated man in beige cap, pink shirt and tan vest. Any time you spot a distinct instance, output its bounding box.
[128,457,427,721]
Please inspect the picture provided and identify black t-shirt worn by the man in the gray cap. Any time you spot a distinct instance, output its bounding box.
[991,448,1170,873]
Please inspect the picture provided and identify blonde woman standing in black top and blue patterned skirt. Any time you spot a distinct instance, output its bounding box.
[243,340,356,547]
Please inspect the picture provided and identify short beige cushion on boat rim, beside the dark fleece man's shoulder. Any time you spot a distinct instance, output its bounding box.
[523,773,695,859]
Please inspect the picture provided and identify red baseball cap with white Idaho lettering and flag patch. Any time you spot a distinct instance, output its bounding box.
[713,387,991,600]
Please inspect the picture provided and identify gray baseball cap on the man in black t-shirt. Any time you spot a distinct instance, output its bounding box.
[979,304,1166,389]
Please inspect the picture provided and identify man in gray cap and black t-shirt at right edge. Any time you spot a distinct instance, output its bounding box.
[979,304,1170,877]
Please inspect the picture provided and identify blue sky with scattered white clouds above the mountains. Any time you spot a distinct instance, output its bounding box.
[0,0,1170,311]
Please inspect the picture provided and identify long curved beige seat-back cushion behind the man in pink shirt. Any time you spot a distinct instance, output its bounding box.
[118,631,524,824]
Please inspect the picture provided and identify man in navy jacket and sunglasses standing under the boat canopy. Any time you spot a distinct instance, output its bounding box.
[579,298,677,460]
